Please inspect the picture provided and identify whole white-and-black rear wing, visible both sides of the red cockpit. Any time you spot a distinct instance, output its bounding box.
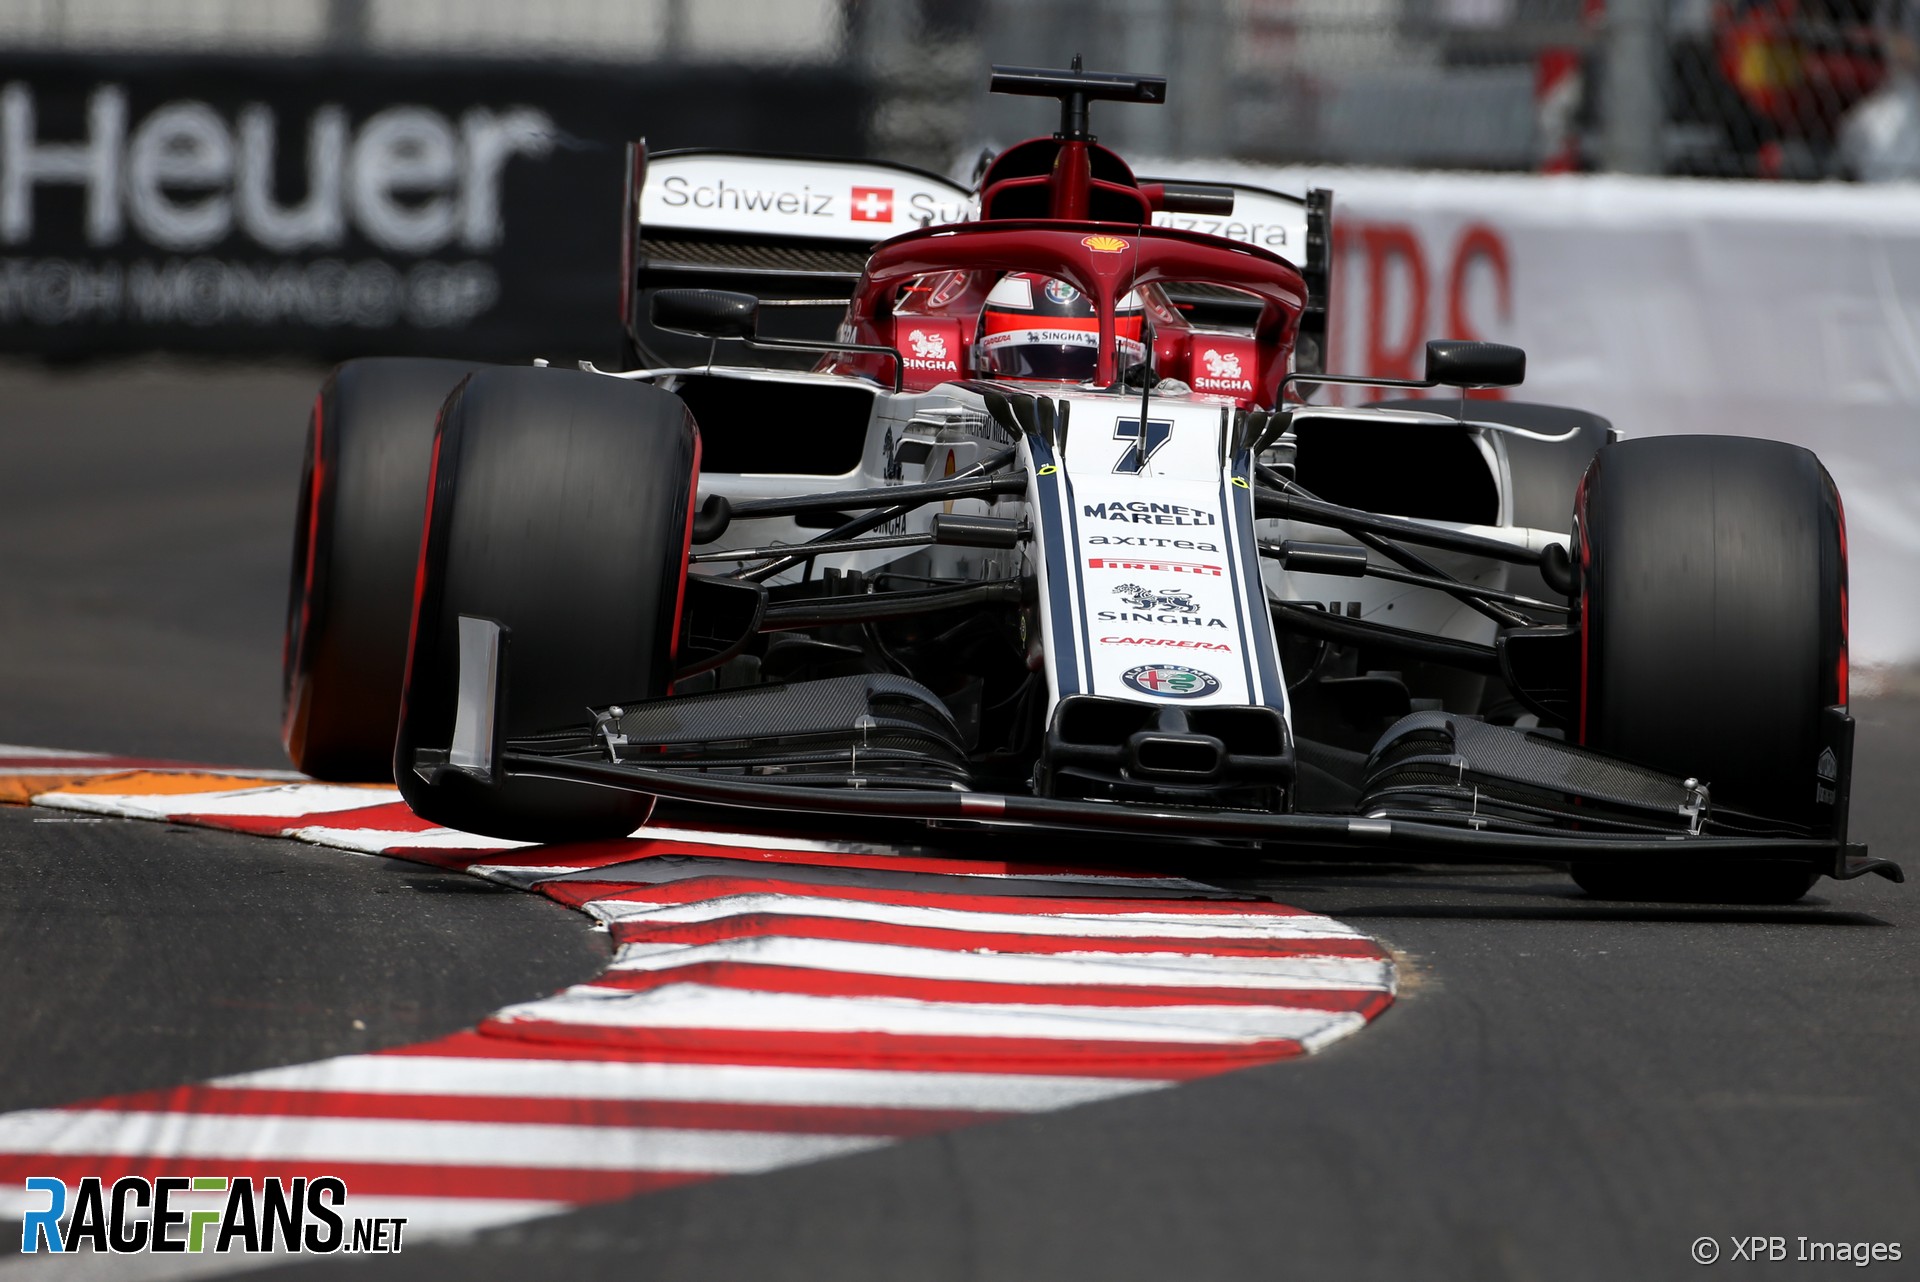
[620,142,1332,372]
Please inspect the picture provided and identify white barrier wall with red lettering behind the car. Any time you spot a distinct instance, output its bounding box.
[1140,163,1920,664]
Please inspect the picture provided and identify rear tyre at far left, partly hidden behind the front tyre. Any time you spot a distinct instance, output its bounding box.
[280,359,476,783]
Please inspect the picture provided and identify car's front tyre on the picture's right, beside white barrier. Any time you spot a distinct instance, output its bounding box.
[1572,436,1847,904]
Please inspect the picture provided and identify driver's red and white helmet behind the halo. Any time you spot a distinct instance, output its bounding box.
[975,273,1146,382]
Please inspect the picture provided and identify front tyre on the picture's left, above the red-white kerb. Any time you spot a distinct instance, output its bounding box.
[394,368,699,841]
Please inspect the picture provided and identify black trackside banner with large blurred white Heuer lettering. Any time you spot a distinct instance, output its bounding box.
[0,56,866,361]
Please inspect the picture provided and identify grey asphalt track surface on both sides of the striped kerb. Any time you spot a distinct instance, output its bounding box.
[0,365,1920,1282]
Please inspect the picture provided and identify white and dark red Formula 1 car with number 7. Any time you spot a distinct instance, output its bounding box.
[284,67,1899,902]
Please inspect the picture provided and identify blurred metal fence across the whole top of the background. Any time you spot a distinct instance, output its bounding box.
[0,0,1920,178]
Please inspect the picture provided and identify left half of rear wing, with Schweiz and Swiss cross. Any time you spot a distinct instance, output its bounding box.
[620,142,973,365]
